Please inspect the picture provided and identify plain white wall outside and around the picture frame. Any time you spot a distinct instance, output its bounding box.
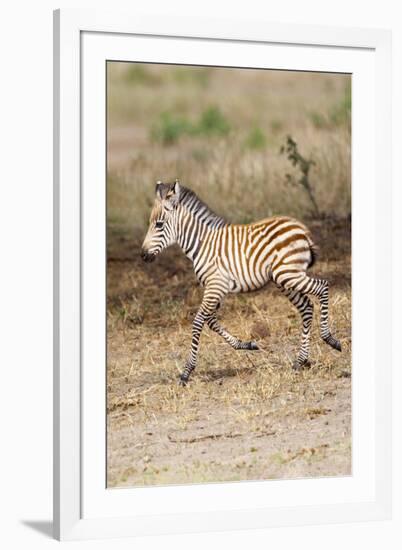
[0,0,402,550]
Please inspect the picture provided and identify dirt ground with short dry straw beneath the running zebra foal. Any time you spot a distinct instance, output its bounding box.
[107,218,351,487]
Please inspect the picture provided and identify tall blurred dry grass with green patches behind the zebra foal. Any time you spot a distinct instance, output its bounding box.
[107,63,351,242]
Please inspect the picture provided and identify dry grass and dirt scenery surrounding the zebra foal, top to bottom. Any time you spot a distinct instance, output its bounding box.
[107,64,351,487]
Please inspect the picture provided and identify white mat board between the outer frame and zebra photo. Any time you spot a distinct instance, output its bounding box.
[82,33,381,532]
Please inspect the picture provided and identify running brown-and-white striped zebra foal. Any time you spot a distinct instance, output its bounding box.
[141,180,341,384]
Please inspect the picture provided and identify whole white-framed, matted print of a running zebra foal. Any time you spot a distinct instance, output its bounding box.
[54,10,391,539]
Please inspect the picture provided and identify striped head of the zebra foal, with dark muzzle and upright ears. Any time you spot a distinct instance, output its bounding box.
[141,180,180,262]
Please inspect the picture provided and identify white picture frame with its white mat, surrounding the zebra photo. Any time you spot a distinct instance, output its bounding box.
[54,10,391,540]
